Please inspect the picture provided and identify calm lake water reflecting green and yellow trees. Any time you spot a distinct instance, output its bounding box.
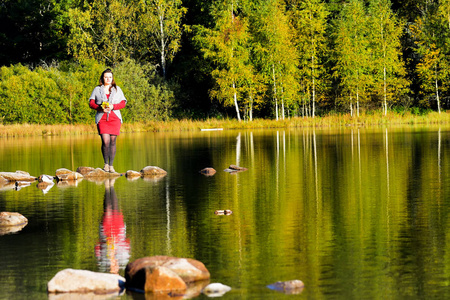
[0,126,450,299]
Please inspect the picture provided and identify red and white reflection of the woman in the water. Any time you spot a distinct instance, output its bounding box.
[95,179,130,274]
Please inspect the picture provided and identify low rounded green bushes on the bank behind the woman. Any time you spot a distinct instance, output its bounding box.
[0,60,177,124]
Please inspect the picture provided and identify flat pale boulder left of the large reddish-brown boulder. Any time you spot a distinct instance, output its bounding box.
[47,269,125,294]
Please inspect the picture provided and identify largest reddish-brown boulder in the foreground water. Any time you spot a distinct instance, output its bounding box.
[125,256,210,293]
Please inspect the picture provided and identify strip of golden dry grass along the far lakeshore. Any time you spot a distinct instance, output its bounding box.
[0,112,450,137]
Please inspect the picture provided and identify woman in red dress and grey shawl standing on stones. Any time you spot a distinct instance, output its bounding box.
[89,69,127,173]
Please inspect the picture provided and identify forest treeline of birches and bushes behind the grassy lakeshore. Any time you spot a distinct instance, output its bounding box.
[0,0,450,124]
